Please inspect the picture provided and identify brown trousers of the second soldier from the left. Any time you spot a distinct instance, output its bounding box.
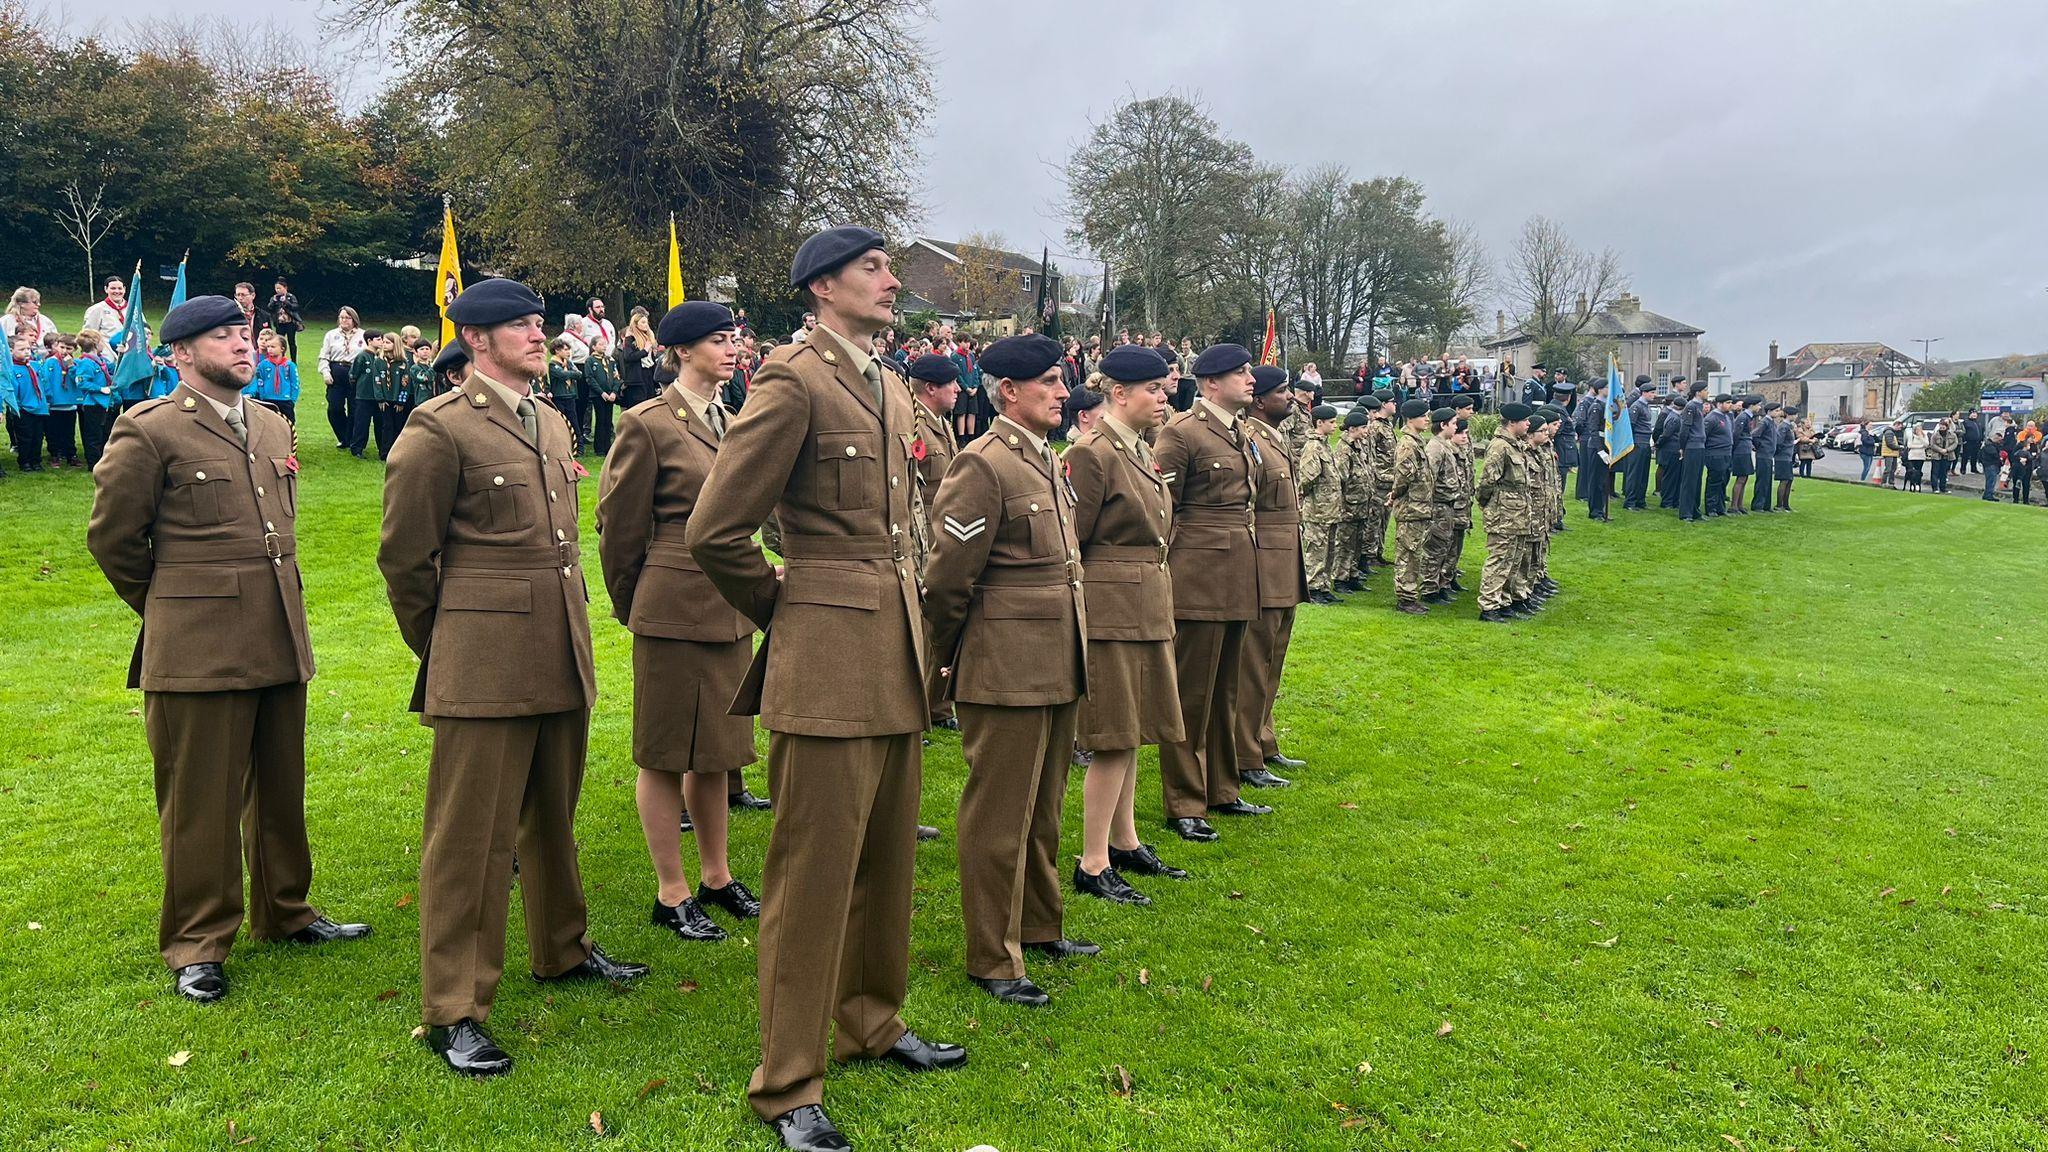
[420,707,590,1025]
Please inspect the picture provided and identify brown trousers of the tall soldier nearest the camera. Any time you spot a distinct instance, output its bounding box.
[748,732,924,1119]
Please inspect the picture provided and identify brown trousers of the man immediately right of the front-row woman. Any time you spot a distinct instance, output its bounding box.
[1159,619,1255,818]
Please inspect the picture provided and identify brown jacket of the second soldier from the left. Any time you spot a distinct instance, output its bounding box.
[377,379,598,717]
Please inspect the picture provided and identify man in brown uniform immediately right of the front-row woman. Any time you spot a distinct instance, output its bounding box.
[1153,344,1272,840]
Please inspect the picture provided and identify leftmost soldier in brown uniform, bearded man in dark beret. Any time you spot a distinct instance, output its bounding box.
[86,295,369,1004]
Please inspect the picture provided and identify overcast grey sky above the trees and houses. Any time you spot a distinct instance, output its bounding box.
[51,0,2048,366]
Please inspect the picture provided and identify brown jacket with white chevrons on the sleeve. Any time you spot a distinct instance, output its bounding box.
[924,416,1087,707]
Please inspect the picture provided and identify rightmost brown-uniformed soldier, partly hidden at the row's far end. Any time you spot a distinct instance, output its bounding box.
[1237,365,1309,787]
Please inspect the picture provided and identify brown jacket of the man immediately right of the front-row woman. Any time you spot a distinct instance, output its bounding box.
[1153,402,1260,621]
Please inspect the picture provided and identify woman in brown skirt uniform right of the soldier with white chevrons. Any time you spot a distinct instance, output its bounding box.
[1065,344,1188,904]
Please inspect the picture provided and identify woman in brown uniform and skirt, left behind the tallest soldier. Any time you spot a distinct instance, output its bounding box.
[598,299,760,941]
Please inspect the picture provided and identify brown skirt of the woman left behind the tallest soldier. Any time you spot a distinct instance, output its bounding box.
[633,635,754,773]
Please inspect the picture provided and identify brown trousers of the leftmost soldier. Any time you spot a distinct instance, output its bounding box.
[141,685,317,968]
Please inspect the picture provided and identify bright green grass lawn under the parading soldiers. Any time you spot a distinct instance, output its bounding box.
[0,309,2048,1152]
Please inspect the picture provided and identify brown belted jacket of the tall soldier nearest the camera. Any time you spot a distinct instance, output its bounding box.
[686,336,930,738]
